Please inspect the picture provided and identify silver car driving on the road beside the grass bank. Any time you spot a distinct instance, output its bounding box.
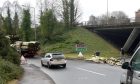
[41,53,67,68]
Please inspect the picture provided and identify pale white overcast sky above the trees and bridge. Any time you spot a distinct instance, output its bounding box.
[0,0,140,21]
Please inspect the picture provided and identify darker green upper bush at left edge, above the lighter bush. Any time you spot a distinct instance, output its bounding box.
[0,32,20,65]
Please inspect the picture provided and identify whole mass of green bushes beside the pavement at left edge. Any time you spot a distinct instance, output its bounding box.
[0,32,23,84]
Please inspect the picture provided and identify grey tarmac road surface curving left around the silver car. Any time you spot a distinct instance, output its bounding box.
[28,58,123,84]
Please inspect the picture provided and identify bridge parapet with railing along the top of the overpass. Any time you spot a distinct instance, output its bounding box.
[80,17,140,28]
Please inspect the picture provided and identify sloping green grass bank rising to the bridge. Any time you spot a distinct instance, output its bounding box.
[42,28,119,58]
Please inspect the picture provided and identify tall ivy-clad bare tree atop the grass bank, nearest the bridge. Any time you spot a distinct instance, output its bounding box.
[62,0,81,27]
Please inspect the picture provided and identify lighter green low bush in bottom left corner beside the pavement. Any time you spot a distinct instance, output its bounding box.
[0,59,23,84]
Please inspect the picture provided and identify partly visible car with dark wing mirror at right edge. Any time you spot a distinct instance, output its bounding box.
[120,46,140,84]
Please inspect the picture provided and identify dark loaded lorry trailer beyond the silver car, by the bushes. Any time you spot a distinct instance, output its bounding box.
[15,41,40,57]
